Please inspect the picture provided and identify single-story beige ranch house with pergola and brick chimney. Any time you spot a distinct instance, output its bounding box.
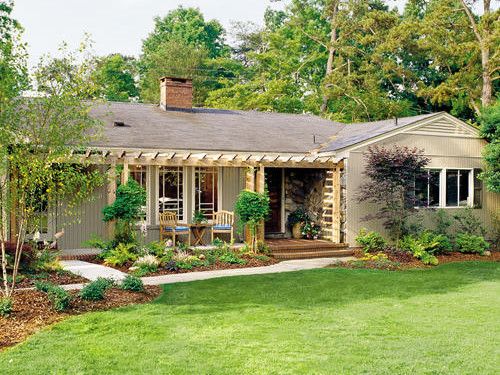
[49,77,499,249]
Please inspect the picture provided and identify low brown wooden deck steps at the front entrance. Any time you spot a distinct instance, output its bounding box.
[266,239,354,259]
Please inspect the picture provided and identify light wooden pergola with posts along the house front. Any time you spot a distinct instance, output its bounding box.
[73,147,343,243]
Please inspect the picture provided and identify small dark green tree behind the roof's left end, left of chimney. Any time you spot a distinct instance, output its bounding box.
[93,53,139,102]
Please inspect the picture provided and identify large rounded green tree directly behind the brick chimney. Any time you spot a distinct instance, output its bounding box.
[139,7,232,105]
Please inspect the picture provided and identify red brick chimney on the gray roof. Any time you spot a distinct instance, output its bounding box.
[160,77,193,110]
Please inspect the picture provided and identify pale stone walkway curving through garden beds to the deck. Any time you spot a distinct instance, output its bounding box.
[61,257,356,290]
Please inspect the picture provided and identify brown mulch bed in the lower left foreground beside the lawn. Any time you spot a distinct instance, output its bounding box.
[0,286,161,351]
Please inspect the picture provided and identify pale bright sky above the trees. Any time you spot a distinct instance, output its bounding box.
[13,0,405,66]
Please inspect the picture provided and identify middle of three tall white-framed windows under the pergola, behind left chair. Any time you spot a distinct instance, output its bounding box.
[158,167,184,221]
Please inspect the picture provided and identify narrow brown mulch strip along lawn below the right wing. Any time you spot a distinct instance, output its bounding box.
[331,249,500,271]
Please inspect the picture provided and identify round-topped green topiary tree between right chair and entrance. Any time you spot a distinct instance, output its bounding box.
[234,190,269,251]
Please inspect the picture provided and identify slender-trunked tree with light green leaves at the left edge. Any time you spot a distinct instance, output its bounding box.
[0,43,103,308]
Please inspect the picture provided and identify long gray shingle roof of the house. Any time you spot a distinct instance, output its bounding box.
[91,102,440,153]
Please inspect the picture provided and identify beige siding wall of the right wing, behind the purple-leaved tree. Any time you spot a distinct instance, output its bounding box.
[346,134,500,245]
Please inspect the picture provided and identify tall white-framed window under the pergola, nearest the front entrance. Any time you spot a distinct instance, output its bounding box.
[194,167,218,219]
